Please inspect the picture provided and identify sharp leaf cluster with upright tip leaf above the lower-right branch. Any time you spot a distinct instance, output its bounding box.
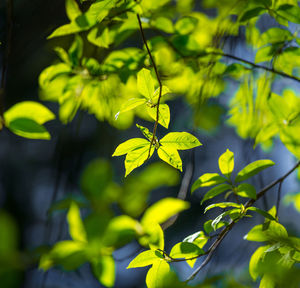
[191,149,274,230]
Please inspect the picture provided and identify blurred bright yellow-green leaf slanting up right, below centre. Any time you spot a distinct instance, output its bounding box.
[141,198,190,225]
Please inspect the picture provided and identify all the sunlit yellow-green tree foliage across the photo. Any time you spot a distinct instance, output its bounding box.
[0,0,300,288]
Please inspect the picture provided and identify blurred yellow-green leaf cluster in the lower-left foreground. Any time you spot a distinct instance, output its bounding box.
[39,198,189,287]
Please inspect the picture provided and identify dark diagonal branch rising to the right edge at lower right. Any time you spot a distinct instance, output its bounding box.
[185,161,300,283]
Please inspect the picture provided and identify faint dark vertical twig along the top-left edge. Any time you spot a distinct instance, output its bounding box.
[0,0,13,130]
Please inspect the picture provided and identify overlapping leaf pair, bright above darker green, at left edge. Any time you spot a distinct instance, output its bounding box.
[4,101,55,140]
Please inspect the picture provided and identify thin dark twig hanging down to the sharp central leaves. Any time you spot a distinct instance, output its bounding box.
[136,14,162,159]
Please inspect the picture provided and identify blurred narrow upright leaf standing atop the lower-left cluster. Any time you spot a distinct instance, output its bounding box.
[67,202,87,242]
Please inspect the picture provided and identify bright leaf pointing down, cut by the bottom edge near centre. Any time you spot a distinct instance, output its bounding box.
[146,259,170,288]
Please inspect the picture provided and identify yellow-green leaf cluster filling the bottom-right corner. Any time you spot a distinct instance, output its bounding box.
[244,207,300,287]
